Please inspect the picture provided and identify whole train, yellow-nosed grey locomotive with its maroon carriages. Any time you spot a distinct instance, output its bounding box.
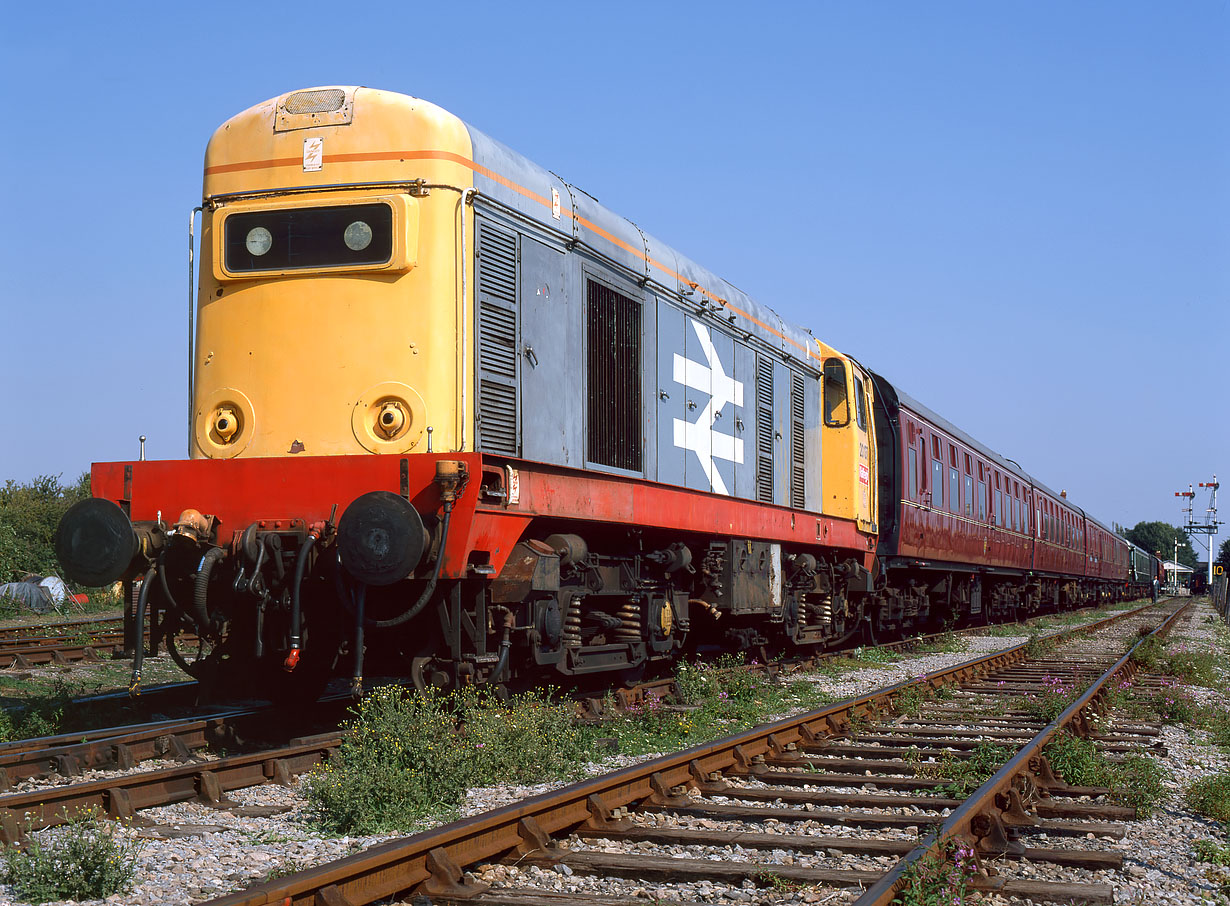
[55,86,1151,693]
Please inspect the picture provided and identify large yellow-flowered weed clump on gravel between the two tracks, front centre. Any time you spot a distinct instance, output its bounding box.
[306,686,583,833]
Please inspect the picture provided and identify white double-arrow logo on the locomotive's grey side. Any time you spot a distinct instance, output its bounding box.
[674,318,743,494]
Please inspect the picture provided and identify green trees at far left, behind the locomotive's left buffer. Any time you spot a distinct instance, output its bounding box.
[0,473,90,583]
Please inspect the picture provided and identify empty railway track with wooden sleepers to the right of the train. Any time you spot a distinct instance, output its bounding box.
[178,599,1178,906]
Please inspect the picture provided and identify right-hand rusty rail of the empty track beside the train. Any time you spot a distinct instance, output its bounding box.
[855,601,1191,906]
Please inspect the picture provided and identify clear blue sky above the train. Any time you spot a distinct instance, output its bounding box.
[0,0,1230,543]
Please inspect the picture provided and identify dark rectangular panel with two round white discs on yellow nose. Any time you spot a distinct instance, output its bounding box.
[225,204,392,273]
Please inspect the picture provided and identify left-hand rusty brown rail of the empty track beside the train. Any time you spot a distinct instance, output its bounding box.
[199,605,1170,906]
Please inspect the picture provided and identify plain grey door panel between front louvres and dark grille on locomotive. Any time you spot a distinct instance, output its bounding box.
[518,236,575,466]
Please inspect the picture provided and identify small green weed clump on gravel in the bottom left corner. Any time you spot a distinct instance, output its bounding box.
[2,811,139,904]
